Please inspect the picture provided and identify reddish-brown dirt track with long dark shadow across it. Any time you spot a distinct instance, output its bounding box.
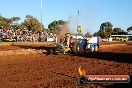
[0,43,132,88]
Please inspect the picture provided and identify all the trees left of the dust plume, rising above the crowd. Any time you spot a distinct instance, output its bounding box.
[0,15,66,34]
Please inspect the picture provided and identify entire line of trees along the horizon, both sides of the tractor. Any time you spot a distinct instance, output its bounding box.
[0,15,132,38]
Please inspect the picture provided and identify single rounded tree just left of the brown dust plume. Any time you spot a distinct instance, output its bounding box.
[48,20,66,34]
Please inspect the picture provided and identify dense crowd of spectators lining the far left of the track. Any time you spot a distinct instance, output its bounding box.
[0,27,56,42]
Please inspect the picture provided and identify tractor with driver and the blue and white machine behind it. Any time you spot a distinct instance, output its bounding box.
[56,33,99,54]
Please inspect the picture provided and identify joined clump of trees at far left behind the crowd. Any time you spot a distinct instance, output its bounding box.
[0,15,45,31]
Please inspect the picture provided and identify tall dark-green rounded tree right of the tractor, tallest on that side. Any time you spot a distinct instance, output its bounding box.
[97,22,113,38]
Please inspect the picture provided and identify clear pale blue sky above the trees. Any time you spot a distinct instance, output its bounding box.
[0,0,132,34]
